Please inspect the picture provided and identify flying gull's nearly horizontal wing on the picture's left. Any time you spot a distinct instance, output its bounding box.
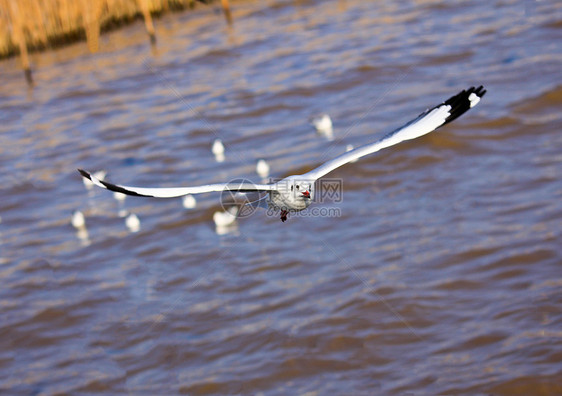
[78,169,275,198]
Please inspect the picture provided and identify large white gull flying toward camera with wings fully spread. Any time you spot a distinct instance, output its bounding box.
[78,86,486,222]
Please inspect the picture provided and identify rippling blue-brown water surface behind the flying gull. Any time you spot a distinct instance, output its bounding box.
[0,0,562,395]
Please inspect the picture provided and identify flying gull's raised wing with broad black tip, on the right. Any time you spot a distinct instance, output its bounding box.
[302,86,486,180]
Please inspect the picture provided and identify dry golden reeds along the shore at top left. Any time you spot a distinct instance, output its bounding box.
[0,0,232,84]
